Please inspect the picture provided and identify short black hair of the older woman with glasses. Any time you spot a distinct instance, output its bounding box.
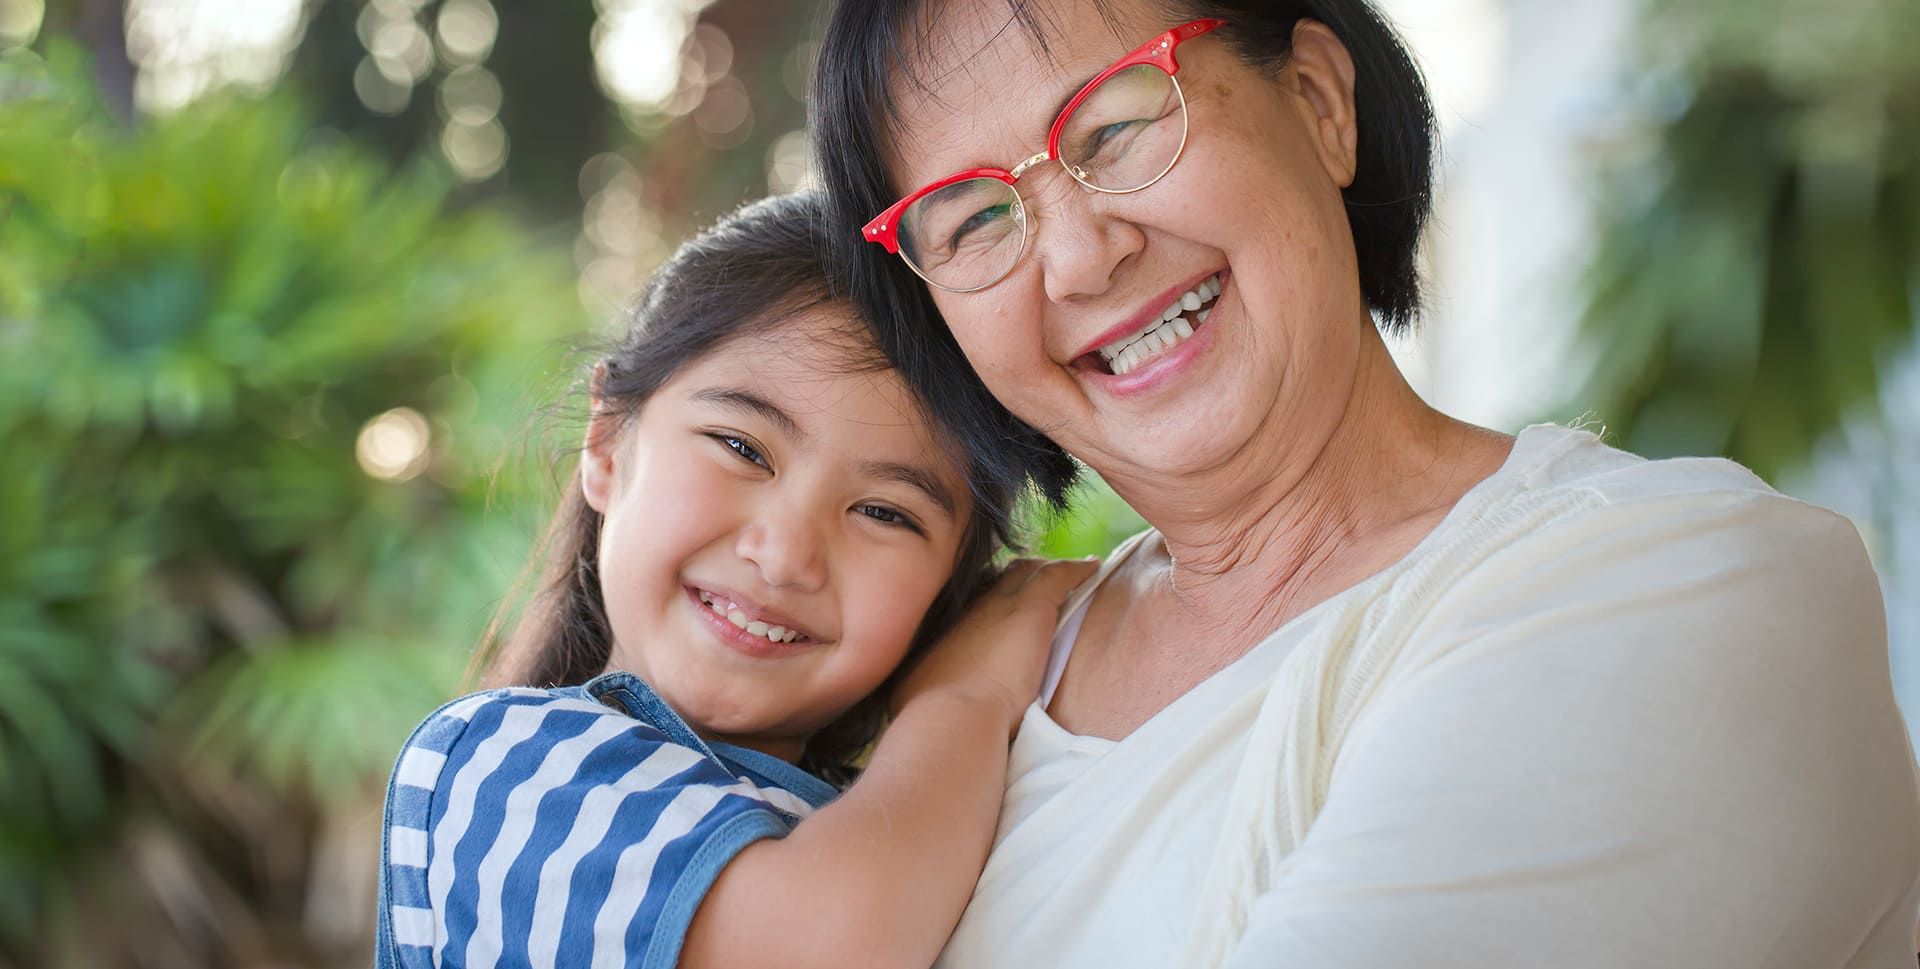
[810,0,1434,495]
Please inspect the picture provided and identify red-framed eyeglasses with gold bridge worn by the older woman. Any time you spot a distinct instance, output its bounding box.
[864,19,1227,294]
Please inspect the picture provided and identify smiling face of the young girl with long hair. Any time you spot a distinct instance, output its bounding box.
[582,307,972,760]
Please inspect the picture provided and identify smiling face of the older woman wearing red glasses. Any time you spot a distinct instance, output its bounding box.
[891,0,1371,482]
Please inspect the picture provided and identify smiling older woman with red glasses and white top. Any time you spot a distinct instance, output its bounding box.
[814,0,1920,969]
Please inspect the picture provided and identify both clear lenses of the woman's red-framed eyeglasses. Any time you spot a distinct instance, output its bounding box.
[899,63,1187,290]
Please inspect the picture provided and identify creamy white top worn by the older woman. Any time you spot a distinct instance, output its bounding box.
[939,426,1920,969]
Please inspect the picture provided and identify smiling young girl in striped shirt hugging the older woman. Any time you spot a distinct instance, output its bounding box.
[376,196,1091,969]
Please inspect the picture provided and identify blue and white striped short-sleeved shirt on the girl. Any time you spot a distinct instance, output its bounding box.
[374,674,837,969]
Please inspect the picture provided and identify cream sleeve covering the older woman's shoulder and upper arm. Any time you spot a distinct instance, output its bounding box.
[1229,491,1920,969]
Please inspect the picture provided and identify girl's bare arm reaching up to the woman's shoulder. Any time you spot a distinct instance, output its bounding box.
[680,562,1094,969]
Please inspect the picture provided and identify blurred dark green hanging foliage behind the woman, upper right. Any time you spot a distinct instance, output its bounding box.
[1571,0,1920,476]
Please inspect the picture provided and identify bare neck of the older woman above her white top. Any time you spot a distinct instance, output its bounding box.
[1116,328,1511,645]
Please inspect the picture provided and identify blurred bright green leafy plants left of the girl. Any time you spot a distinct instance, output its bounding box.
[0,46,584,963]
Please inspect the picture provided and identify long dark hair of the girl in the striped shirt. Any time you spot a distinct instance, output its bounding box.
[478,192,1020,783]
